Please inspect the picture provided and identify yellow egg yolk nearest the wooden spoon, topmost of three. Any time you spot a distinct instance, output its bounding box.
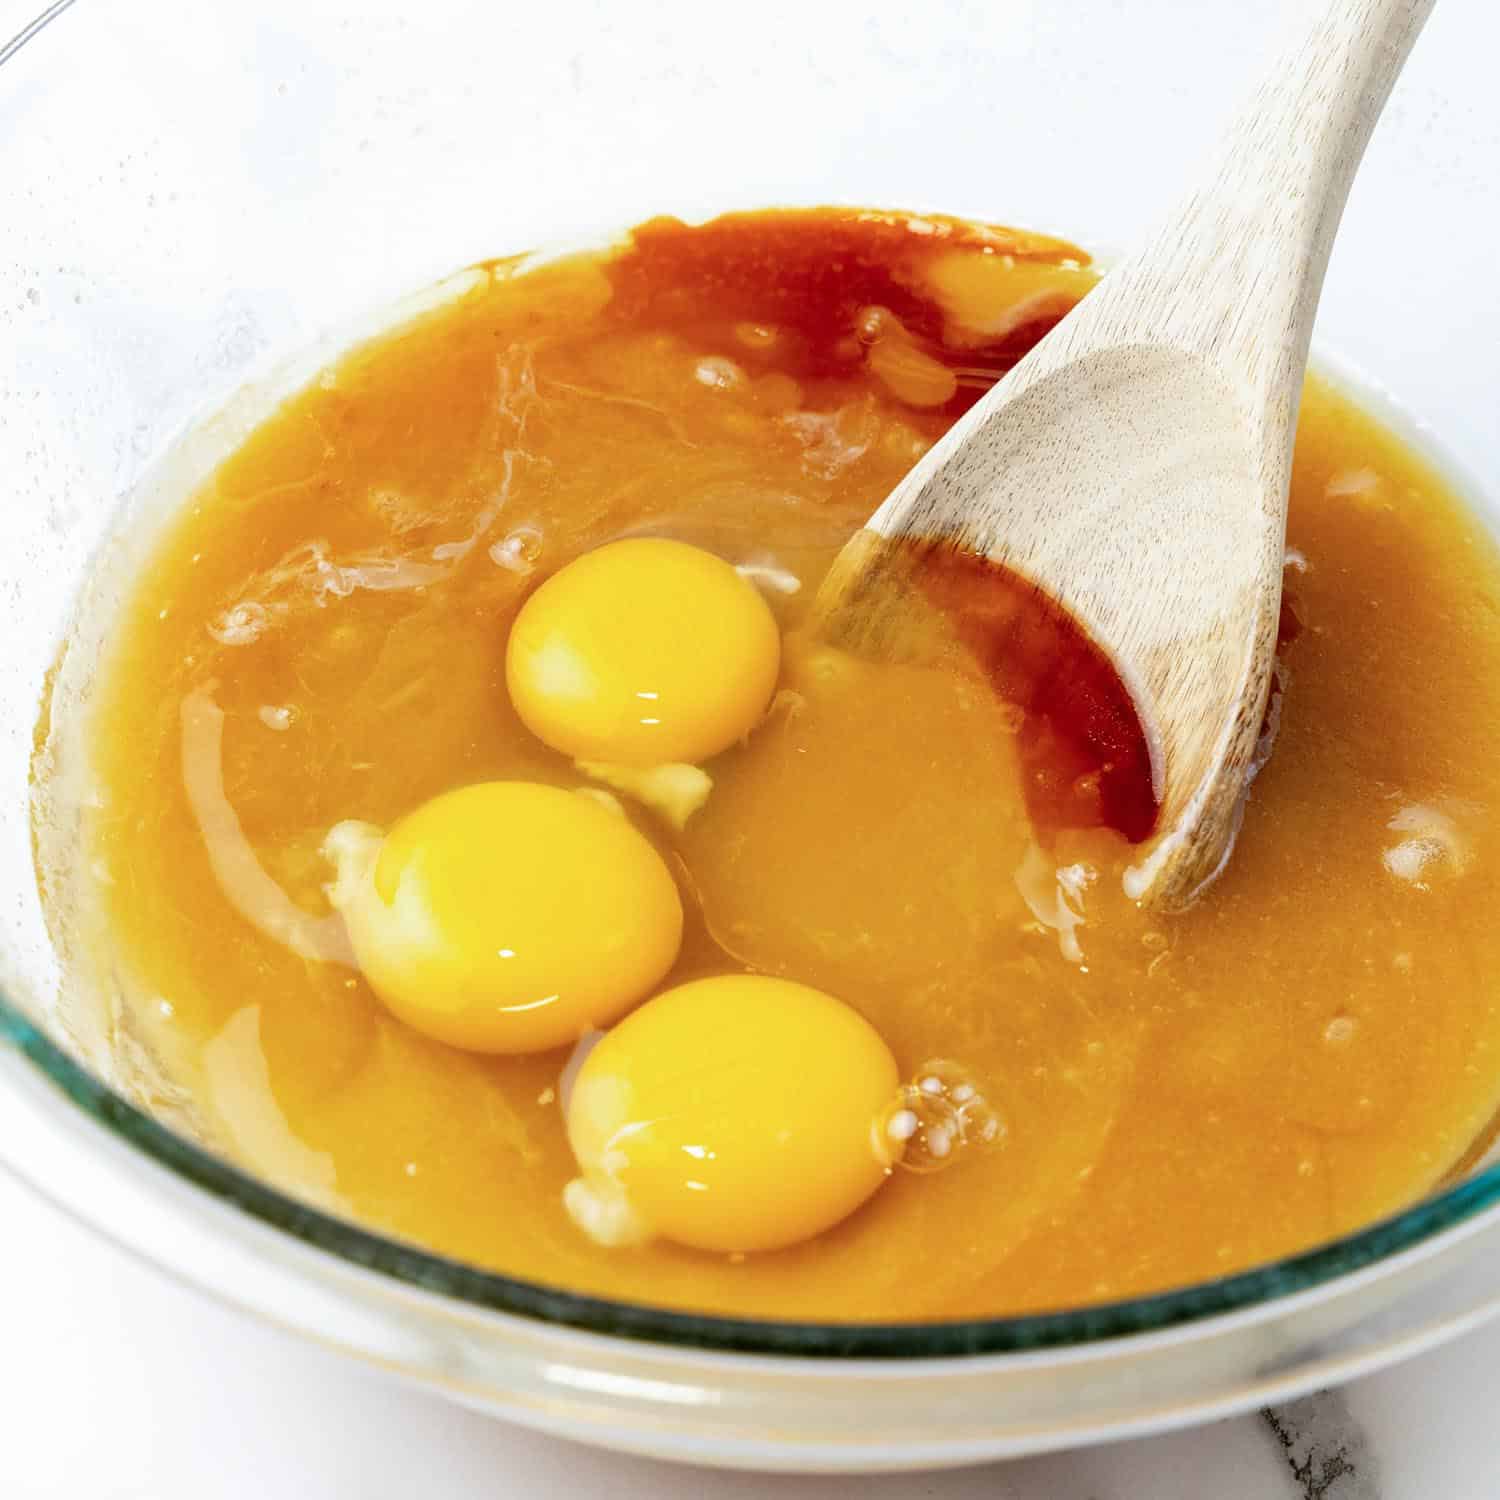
[506,537,782,767]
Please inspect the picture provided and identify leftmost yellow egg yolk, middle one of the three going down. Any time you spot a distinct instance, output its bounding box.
[324,782,683,1053]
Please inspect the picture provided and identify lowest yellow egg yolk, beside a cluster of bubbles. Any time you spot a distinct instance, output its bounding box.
[564,975,900,1251]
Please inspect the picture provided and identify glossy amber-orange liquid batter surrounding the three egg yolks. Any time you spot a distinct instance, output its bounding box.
[61,212,1500,1320]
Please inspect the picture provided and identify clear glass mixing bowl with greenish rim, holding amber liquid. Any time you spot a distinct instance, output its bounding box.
[0,0,1500,1469]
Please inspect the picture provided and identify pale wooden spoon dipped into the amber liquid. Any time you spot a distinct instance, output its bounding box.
[818,0,1434,909]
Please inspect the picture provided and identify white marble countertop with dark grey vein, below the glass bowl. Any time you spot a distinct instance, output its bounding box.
[0,1176,1500,1500]
